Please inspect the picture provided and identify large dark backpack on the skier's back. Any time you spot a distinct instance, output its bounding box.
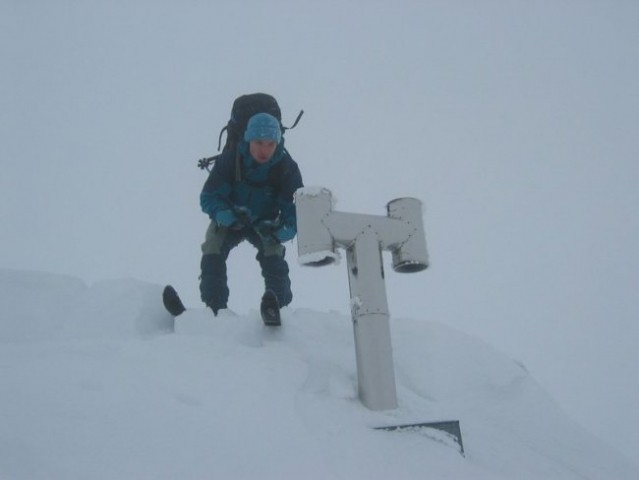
[198,93,304,170]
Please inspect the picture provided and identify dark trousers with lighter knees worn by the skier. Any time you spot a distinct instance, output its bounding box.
[200,223,293,312]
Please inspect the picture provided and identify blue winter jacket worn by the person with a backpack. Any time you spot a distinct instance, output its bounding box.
[200,139,304,235]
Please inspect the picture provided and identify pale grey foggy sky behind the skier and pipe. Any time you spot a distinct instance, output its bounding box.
[0,0,639,464]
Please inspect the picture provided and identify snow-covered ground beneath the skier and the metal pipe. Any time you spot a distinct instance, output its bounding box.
[0,269,639,480]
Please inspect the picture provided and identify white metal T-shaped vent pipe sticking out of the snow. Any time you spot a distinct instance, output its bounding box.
[295,188,428,410]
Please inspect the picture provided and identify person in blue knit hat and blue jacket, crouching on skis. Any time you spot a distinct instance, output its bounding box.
[200,113,303,316]
